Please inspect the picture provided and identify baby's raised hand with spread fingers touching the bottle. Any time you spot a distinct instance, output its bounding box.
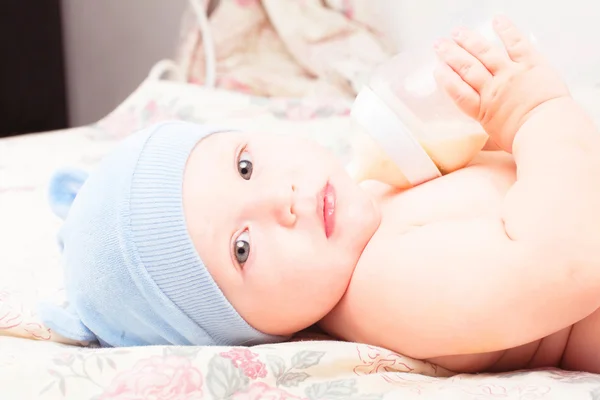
[435,17,569,152]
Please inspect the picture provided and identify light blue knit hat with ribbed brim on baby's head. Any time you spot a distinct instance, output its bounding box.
[39,122,285,347]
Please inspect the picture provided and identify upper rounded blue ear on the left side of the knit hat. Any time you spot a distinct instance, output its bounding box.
[48,168,89,220]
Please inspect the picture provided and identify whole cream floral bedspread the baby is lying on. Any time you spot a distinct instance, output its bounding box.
[0,74,600,400]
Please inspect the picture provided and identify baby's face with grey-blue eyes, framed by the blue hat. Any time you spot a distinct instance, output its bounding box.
[183,132,380,335]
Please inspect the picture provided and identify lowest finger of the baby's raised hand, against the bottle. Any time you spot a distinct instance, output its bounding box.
[434,63,481,118]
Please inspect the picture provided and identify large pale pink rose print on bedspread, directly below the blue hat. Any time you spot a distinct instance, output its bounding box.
[100,356,203,400]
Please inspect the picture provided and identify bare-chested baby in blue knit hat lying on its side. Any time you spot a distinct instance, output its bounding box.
[40,17,600,372]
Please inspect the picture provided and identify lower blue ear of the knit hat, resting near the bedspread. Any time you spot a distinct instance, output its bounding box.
[38,301,97,342]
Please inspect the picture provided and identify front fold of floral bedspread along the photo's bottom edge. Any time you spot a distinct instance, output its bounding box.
[5,337,600,400]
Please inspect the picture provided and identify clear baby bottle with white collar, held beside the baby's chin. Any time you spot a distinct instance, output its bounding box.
[346,20,528,189]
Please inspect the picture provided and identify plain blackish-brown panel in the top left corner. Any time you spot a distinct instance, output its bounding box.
[0,0,68,137]
